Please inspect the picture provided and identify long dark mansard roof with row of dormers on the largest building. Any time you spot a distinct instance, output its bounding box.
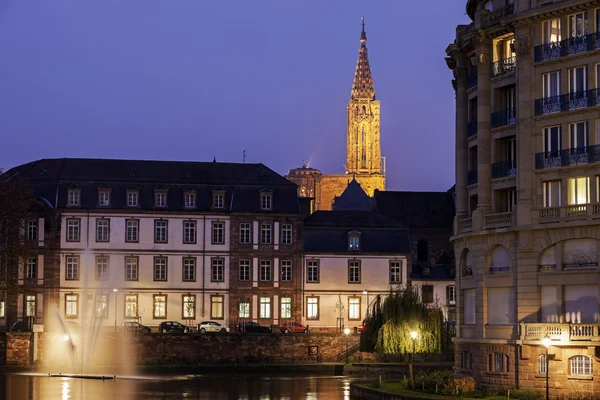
[7,158,300,213]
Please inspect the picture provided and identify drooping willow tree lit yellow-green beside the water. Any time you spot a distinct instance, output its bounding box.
[361,288,444,354]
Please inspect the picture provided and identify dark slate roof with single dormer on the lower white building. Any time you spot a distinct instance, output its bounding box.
[302,211,410,255]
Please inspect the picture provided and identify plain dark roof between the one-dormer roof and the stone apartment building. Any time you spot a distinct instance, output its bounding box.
[375,191,454,229]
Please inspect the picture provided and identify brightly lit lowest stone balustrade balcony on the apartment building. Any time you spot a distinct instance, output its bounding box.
[520,323,600,345]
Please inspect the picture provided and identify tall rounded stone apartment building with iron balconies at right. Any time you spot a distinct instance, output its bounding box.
[446,0,600,397]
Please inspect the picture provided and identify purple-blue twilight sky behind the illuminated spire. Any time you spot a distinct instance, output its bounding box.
[0,0,468,190]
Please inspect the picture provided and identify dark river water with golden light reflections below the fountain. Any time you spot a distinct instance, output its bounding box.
[0,373,350,400]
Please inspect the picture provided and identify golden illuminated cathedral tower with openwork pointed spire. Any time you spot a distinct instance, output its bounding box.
[346,19,382,174]
